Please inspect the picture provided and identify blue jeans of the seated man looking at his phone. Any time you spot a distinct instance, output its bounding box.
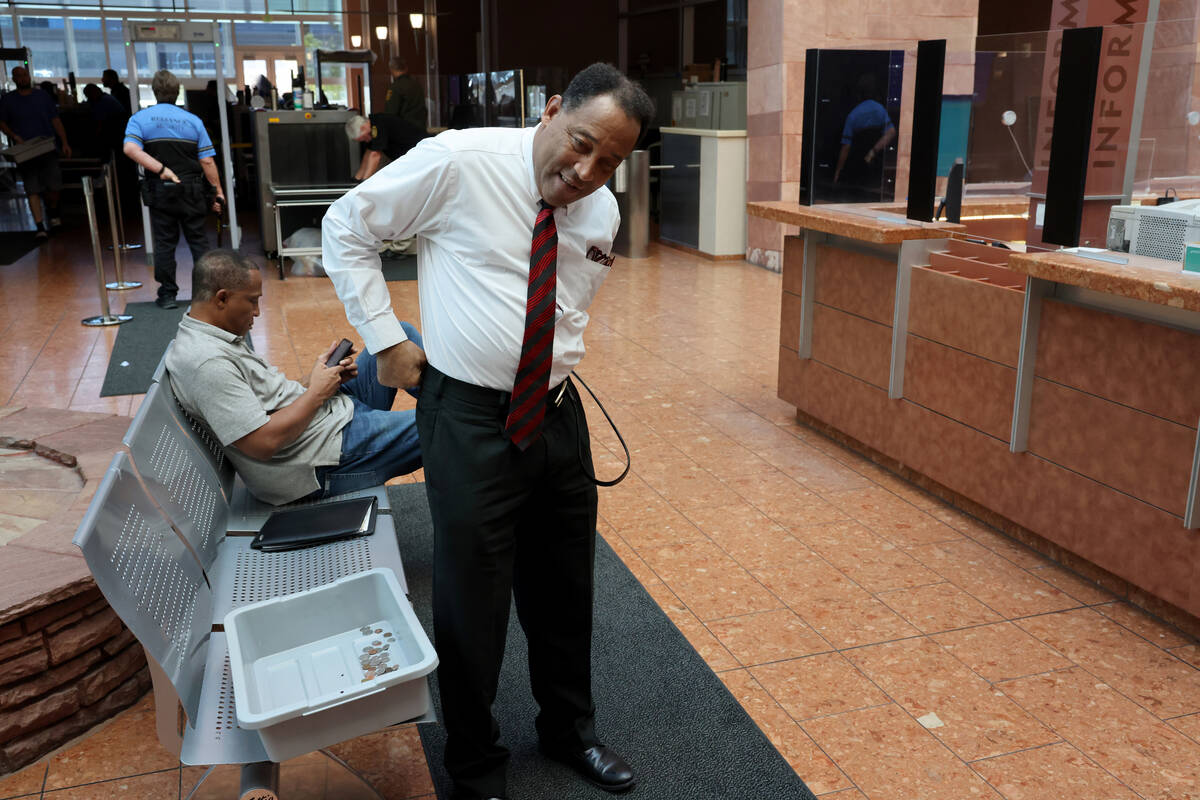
[317,323,424,497]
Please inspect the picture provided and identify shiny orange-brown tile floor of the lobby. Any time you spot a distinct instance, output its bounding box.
[0,220,1200,800]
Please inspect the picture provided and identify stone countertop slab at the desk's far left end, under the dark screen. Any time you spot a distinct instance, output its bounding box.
[746,200,966,245]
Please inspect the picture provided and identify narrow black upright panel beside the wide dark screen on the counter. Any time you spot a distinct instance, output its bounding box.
[906,38,946,222]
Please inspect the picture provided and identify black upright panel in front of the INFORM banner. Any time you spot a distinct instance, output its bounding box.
[1042,28,1104,247]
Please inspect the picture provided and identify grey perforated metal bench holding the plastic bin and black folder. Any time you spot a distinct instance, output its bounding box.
[74,357,432,786]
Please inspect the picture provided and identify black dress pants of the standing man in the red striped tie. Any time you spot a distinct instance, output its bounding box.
[416,367,596,796]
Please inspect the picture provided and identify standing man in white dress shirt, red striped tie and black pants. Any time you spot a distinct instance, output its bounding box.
[323,64,654,799]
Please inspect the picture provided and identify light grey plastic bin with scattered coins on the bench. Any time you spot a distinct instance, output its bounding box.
[224,569,438,762]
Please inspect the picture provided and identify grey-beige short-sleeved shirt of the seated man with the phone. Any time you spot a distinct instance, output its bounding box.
[167,314,354,504]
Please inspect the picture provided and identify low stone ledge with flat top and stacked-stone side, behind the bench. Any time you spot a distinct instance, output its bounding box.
[0,407,150,775]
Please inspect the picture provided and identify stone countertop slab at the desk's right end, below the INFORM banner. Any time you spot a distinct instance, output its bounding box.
[1008,251,1200,311]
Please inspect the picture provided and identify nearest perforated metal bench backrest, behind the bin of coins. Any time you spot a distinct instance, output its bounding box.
[73,453,212,721]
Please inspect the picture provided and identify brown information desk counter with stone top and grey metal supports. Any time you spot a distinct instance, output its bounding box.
[748,203,1200,632]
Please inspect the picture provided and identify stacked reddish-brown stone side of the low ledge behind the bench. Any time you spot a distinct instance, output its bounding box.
[0,585,150,775]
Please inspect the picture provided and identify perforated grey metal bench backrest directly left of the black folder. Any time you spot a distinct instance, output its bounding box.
[124,381,229,571]
